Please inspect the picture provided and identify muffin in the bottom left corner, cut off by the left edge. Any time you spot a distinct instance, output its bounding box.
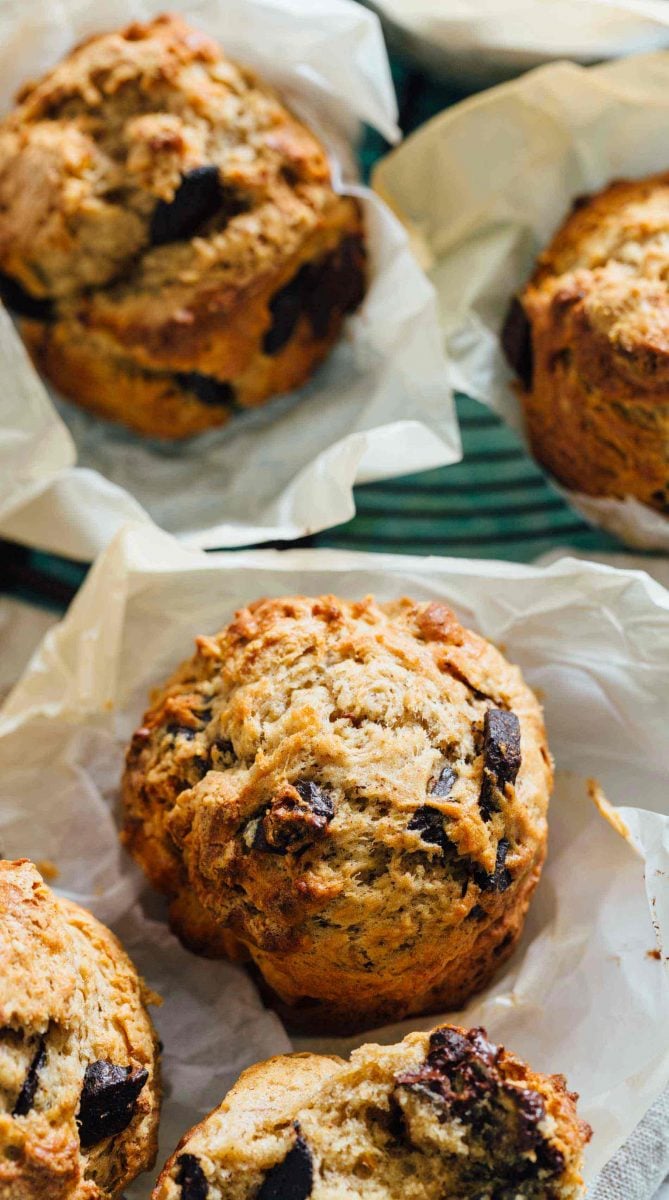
[0,860,159,1200]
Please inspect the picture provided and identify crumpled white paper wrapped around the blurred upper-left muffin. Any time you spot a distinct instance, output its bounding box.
[0,0,460,560]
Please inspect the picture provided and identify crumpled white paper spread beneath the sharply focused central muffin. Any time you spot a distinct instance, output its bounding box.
[0,526,669,1200]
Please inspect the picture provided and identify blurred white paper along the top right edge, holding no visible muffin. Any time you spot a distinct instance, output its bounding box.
[368,0,669,89]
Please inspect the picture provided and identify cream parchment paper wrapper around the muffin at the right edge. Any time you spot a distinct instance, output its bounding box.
[374,49,669,551]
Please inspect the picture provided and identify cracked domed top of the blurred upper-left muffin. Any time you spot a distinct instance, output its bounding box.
[0,16,335,304]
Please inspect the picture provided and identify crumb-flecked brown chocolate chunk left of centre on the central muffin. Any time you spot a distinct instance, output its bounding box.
[252,780,335,854]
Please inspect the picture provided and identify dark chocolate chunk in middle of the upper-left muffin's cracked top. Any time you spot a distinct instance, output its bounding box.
[149,166,248,246]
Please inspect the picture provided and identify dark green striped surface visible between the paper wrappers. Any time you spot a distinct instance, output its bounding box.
[0,62,657,608]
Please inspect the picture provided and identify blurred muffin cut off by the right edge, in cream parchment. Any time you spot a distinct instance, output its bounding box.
[502,174,669,514]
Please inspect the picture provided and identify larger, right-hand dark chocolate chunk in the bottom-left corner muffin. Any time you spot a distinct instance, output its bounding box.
[77,1058,149,1150]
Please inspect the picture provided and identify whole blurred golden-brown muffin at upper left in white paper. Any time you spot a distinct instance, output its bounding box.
[0,16,364,438]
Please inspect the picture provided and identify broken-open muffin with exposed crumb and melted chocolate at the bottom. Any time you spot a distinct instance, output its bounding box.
[152,1025,590,1200]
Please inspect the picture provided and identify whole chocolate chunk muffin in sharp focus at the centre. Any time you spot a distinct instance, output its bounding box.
[122,596,552,1032]
